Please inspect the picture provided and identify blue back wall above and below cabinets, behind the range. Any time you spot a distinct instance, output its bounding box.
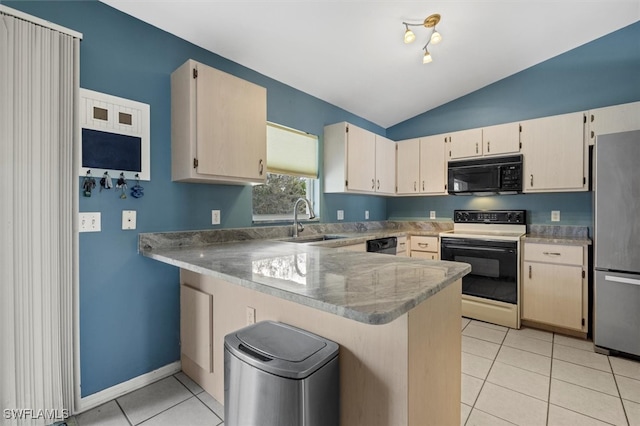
[387,22,640,227]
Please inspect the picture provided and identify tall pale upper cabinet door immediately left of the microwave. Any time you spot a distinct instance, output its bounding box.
[420,135,447,195]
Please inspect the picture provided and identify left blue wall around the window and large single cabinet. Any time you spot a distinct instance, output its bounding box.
[2,1,387,397]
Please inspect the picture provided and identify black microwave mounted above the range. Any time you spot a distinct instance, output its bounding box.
[447,154,522,195]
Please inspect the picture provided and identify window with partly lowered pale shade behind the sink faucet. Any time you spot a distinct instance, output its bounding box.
[253,123,319,222]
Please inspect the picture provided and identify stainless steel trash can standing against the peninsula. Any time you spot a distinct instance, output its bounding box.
[224,321,340,426]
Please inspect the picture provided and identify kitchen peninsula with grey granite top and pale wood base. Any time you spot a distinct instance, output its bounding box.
[140,227,470,426]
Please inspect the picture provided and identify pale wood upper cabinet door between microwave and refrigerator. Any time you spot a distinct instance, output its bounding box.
[520,112,588,192]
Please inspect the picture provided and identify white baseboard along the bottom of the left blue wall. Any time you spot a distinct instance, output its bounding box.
[72,361,182,415]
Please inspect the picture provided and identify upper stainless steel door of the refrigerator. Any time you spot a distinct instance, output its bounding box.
[594,131,640,273]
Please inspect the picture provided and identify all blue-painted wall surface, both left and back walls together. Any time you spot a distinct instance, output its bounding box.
[7,0,640,396]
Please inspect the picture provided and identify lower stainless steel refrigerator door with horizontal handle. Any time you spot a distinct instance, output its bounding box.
[593,270,640,356]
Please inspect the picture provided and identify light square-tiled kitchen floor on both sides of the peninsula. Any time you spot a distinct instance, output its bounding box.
[67,318,640,426]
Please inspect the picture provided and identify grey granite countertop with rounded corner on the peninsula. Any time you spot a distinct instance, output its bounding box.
[140,221,471,324]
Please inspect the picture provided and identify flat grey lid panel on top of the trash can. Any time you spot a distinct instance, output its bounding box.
[236,321,327,362]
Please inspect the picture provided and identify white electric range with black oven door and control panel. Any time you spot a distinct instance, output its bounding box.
[440,210,527,328]
